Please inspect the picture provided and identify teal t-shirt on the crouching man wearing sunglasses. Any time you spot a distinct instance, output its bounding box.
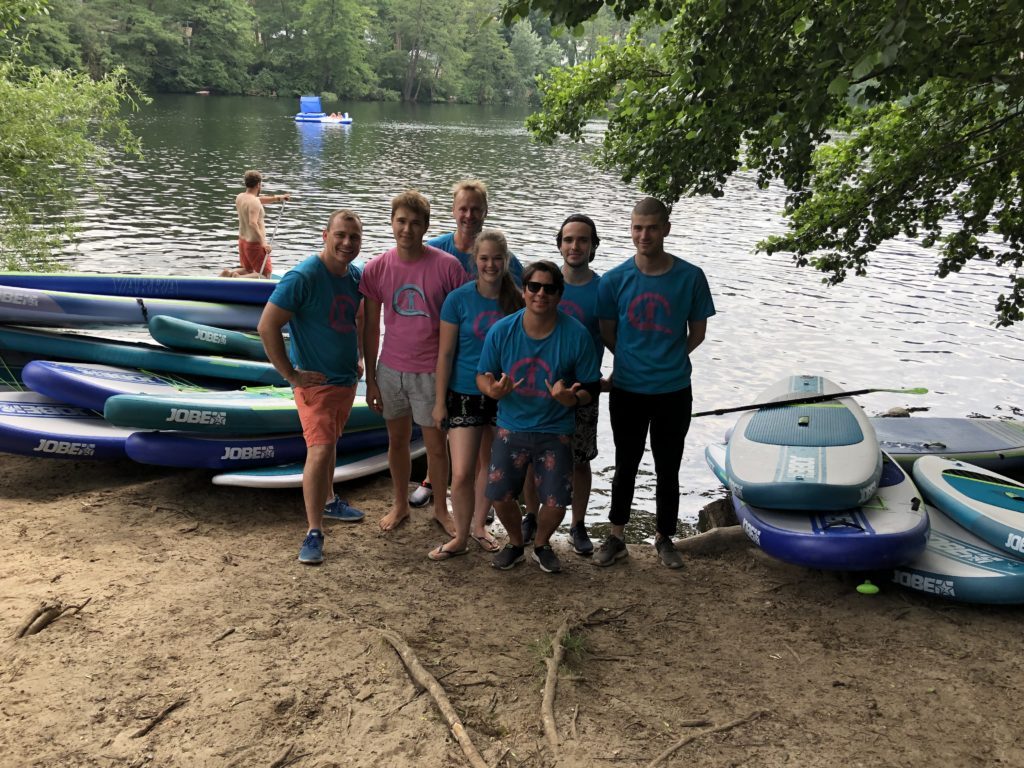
[477,309,601,434]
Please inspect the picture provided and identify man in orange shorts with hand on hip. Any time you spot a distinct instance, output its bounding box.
[259,210,362,564]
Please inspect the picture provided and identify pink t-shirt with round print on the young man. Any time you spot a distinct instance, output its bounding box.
[359,245,469,374]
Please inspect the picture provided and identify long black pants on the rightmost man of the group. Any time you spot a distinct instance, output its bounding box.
[608,387,693,537]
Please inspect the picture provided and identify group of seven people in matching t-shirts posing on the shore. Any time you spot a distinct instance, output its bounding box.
[247,174,715,572]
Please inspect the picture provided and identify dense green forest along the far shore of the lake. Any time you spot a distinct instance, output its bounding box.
[13,0,627,104]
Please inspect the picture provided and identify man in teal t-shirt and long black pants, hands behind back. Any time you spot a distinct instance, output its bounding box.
[594,198,715,568]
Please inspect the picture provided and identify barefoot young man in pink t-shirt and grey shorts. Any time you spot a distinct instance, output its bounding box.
[359,189,469,536]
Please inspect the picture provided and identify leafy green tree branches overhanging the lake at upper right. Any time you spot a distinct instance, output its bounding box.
[504,0,1024,326]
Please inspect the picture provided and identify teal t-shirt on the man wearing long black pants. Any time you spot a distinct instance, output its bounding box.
[597,256,715,394]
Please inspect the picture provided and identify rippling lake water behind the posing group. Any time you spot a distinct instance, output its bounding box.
[58,96,1024,534]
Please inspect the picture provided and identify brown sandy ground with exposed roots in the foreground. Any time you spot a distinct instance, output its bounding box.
[0,456,1024,768]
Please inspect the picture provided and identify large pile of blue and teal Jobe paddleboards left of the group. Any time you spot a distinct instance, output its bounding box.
[0,271,395,485]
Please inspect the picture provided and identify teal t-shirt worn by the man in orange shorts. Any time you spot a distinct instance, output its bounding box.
[270,255,362,386]
